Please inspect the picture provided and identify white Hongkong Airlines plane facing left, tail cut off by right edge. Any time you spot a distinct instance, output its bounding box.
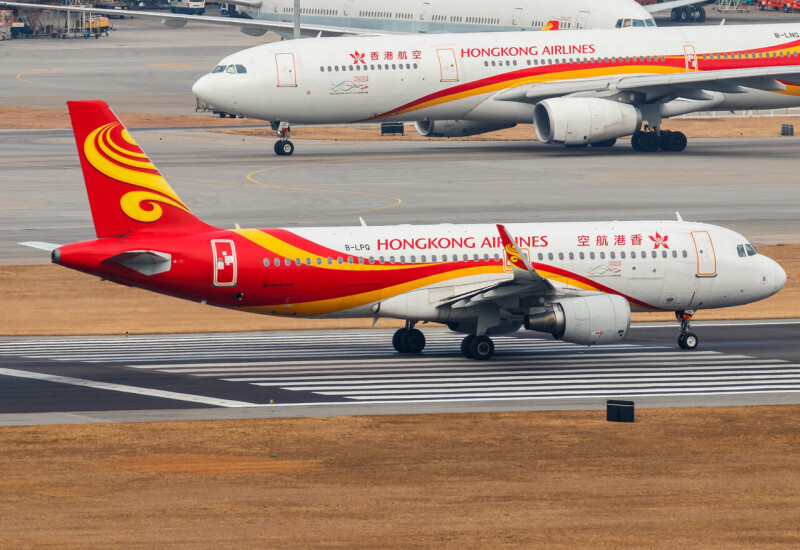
[192,23,800,154]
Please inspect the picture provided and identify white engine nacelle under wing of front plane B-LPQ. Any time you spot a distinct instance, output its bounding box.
[524,294,631,346]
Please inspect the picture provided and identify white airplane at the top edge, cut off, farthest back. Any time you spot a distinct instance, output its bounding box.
[0,0,707,37]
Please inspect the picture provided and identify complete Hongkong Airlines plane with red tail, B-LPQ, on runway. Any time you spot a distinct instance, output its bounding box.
[23,101,786,359]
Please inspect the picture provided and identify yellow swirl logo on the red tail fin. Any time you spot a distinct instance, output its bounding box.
[83,122,189,223]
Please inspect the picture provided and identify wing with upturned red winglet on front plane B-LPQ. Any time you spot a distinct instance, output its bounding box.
[438,224,555,309]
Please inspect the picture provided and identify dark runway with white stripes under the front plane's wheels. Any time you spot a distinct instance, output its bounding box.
[0,321,800,424]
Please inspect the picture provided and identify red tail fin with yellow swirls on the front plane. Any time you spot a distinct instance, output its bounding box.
[67,101,211,238]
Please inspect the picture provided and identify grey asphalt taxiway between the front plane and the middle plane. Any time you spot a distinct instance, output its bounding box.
[0,129,800,264]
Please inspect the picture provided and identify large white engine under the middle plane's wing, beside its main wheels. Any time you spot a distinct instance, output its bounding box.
[533,97,642,145]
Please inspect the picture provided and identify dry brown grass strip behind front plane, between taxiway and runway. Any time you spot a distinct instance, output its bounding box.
[0,245,800,336]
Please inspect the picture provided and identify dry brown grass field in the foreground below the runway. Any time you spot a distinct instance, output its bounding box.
[0,406,800,548]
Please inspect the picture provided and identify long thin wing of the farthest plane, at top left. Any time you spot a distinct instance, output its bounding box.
[0,0,390,36]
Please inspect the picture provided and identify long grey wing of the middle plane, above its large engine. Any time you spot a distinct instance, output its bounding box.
[495,65,800,103]
